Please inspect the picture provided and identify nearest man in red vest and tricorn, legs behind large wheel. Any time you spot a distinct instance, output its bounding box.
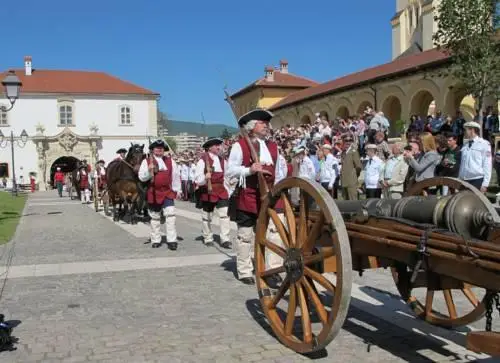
[227,109,287,288]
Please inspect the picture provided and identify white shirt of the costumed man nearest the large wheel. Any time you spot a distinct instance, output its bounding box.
[226,139,287,188]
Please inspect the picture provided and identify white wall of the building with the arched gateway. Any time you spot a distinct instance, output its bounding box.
[0,95,157,185]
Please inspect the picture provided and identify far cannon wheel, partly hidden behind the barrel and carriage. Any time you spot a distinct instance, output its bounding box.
[392,177,500,328]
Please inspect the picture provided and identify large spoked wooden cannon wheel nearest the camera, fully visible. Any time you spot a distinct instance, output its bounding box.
[255,177,352,353]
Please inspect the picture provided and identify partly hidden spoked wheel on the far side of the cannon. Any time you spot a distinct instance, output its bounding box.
[392,177,500,328]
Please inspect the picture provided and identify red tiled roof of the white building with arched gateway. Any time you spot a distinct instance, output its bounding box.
[0,69,158,95]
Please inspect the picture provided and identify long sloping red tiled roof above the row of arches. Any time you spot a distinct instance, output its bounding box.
[269,49,450,111]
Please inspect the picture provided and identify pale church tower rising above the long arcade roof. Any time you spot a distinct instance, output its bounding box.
[391,0,441,59]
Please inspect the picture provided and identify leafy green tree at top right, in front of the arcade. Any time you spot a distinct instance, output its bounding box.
[433,0,500,134]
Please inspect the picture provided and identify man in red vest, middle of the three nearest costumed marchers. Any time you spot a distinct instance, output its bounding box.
[194,138,231,248]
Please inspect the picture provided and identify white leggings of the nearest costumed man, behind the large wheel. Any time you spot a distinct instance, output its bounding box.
[236,213,287,279]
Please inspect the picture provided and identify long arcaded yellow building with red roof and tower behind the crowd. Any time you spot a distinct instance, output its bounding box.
[229,0,497,134]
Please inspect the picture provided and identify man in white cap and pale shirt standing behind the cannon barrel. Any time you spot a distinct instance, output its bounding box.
[458,121,492,193]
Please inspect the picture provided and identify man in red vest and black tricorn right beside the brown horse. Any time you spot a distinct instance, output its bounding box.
[139,140,182,251]
